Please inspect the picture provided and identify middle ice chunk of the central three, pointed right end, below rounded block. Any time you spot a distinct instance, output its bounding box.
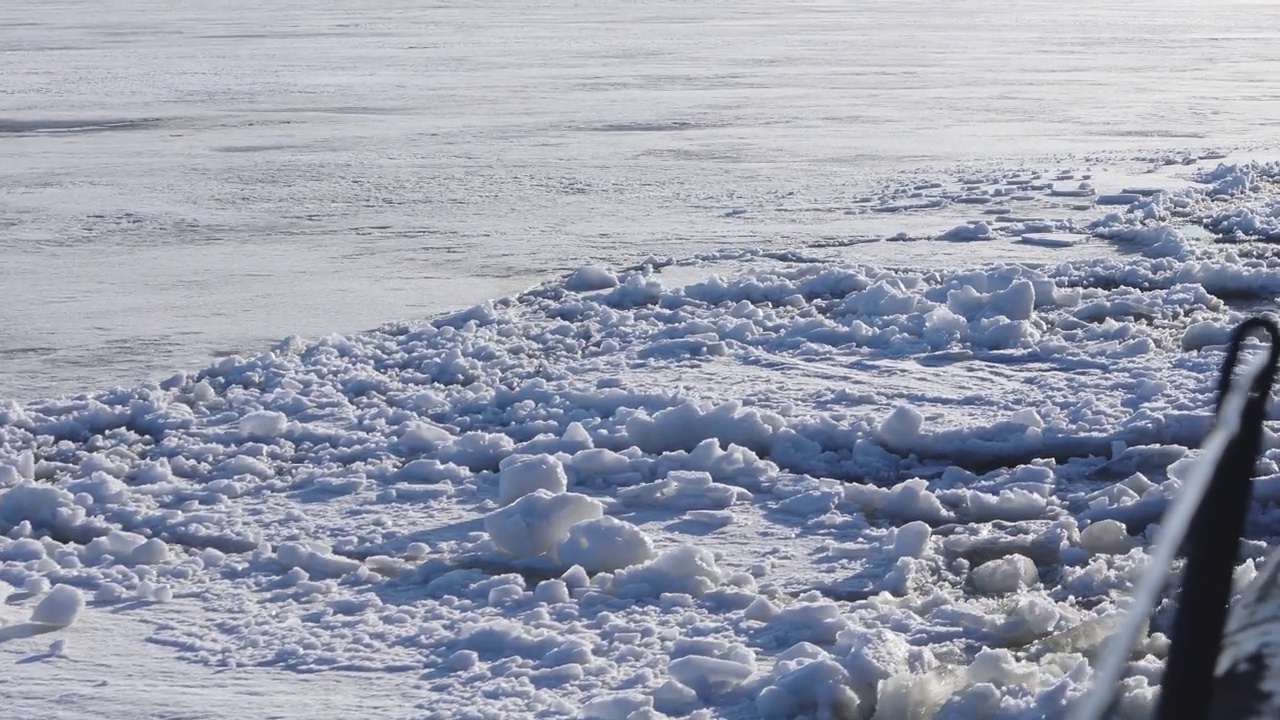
[484,489,604,557]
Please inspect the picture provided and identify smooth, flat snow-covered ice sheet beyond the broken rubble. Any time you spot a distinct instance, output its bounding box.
[0,0,1280,398]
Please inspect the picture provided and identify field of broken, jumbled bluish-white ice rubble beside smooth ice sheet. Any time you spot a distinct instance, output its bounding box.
[10,158,1280,720]
